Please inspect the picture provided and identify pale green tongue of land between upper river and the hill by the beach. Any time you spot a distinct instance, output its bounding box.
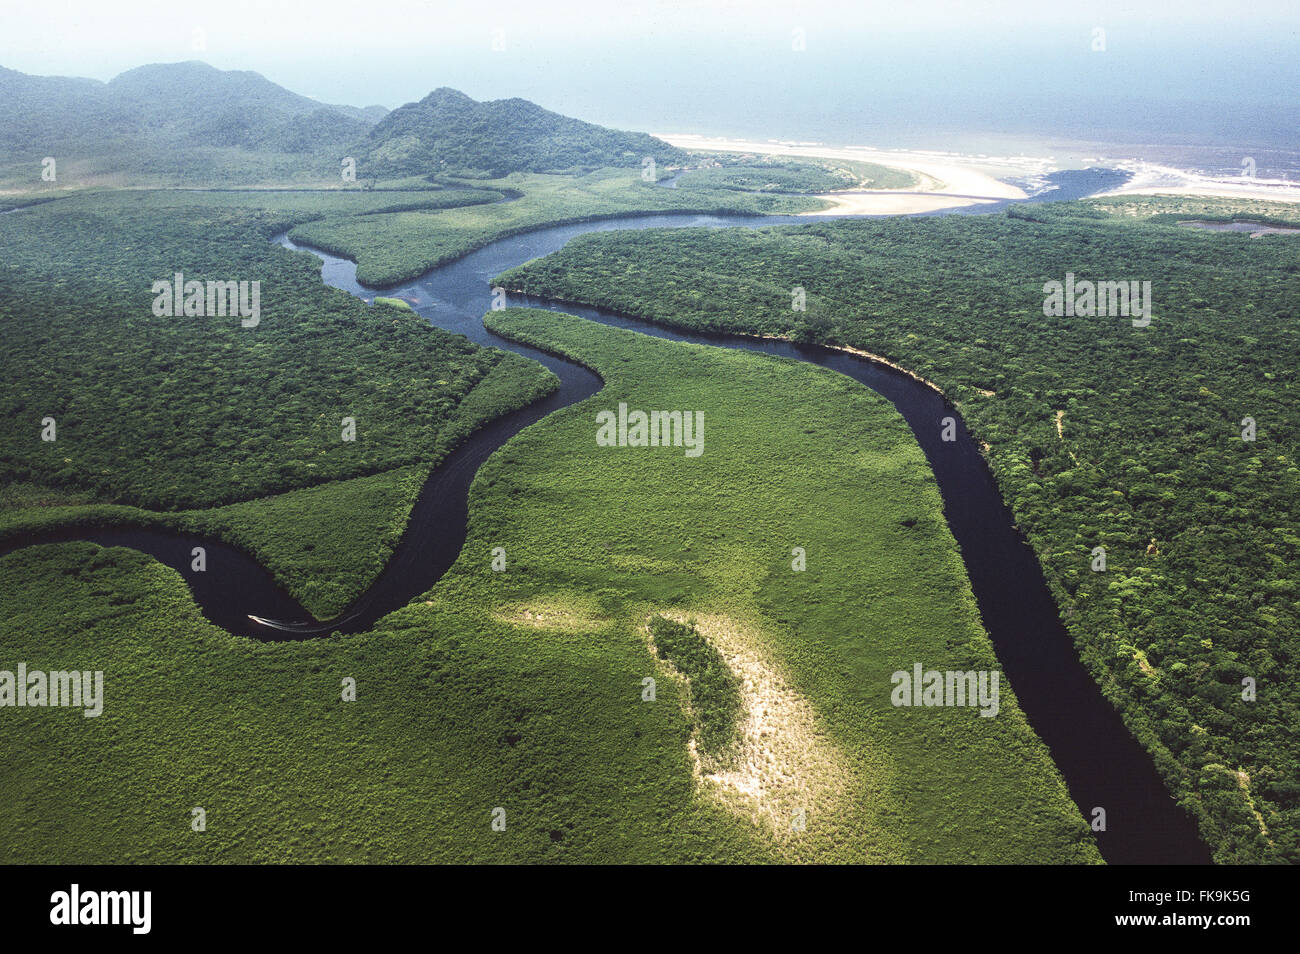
[290,169,827,287]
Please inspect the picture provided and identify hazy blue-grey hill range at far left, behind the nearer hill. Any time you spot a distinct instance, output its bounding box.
[0,61,384,159]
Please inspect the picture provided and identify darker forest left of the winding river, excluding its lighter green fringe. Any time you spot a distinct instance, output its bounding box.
[0,196,553,509]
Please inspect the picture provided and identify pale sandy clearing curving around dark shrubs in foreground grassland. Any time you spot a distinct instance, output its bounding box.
[645,612,852,846]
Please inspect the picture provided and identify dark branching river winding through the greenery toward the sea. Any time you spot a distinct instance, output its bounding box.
[5,164,1209,864]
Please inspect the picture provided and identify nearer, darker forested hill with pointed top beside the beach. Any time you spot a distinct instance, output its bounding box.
[360,87,685,178]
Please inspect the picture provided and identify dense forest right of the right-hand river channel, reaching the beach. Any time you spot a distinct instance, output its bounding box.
[497,198,1300,862]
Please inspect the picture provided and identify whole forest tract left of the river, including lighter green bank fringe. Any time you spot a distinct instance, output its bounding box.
[0,191,555,615]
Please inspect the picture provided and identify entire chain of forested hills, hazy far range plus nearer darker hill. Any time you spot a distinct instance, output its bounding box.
[0,61,685,179]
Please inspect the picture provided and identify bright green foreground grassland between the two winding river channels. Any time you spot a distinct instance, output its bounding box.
[0,309,1099,862]
